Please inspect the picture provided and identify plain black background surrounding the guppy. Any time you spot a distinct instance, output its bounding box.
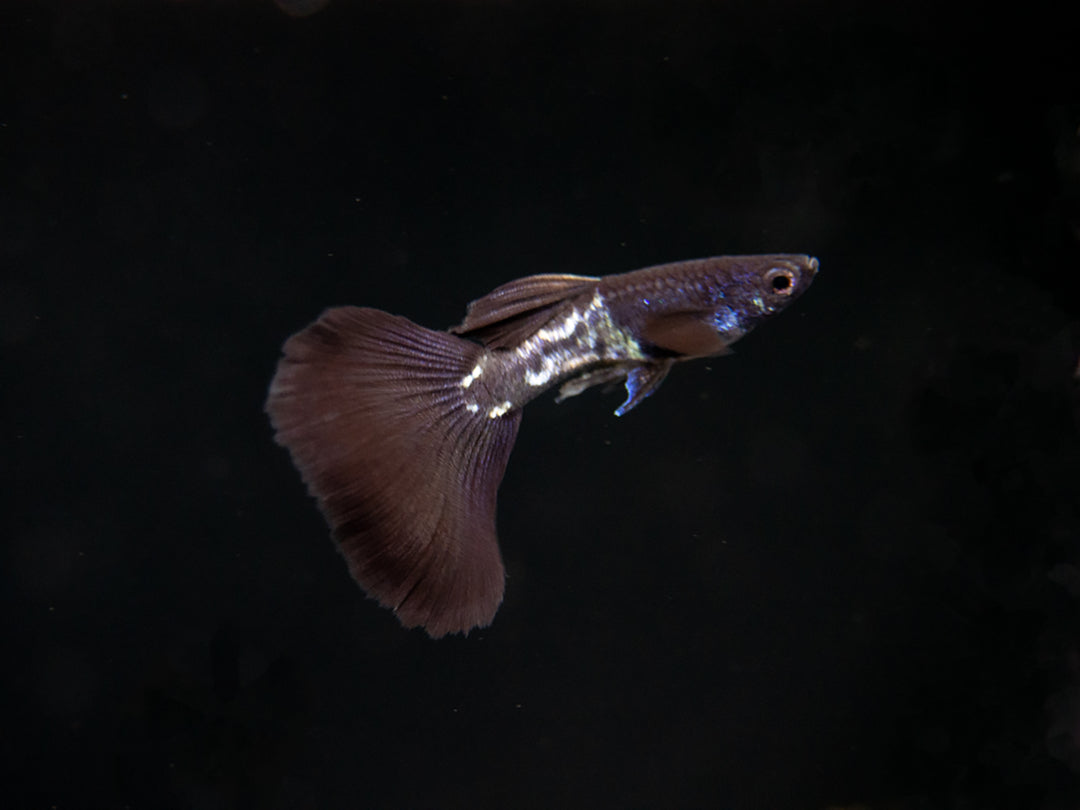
[6,0,1080,810]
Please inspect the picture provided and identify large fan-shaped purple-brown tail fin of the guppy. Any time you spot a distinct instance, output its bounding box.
[267,307,521,637]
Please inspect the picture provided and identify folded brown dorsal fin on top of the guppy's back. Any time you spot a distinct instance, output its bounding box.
[449,273,599,349]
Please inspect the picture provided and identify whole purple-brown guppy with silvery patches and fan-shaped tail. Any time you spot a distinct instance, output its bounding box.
[266,254,818,637]
